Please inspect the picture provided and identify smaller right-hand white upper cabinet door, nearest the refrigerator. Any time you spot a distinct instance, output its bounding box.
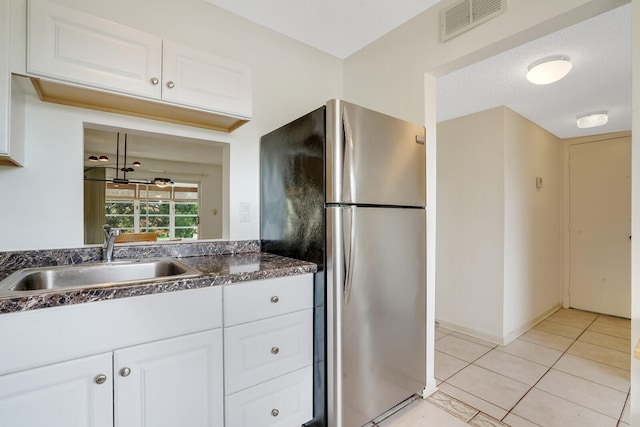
[162,40,252,117]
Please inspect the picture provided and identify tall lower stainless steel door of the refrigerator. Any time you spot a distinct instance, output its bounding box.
[327,206,426,427]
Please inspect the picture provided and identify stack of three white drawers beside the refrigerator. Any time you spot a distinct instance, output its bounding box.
[223,274,313,427]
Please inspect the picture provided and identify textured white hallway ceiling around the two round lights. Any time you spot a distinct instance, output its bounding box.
[437,4,631,138]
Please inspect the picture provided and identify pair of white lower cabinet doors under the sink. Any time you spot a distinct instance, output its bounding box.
[0,329,224,427]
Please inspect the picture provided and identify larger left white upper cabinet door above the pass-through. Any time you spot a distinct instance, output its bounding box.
[27,0,162,99]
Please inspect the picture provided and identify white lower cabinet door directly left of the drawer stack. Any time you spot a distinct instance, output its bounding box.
[113,329,224,427]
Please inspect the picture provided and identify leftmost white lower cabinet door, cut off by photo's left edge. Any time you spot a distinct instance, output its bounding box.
[0,353,113,427]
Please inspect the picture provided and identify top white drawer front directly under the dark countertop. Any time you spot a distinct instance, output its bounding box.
[223,274,313,326]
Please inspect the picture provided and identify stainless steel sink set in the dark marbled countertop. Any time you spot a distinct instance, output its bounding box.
[0,259,201,296]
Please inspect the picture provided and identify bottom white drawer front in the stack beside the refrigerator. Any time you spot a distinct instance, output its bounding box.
[225,366,313,427]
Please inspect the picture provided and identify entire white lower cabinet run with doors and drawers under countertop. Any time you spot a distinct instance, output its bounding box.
[0,274,313,427]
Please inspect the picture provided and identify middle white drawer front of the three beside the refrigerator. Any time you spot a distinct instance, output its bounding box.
[224,310,313,394]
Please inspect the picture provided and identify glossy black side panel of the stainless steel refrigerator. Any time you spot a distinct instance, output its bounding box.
[260,107,327,427]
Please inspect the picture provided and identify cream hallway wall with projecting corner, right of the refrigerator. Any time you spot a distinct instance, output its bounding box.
[436,107,563,344]
